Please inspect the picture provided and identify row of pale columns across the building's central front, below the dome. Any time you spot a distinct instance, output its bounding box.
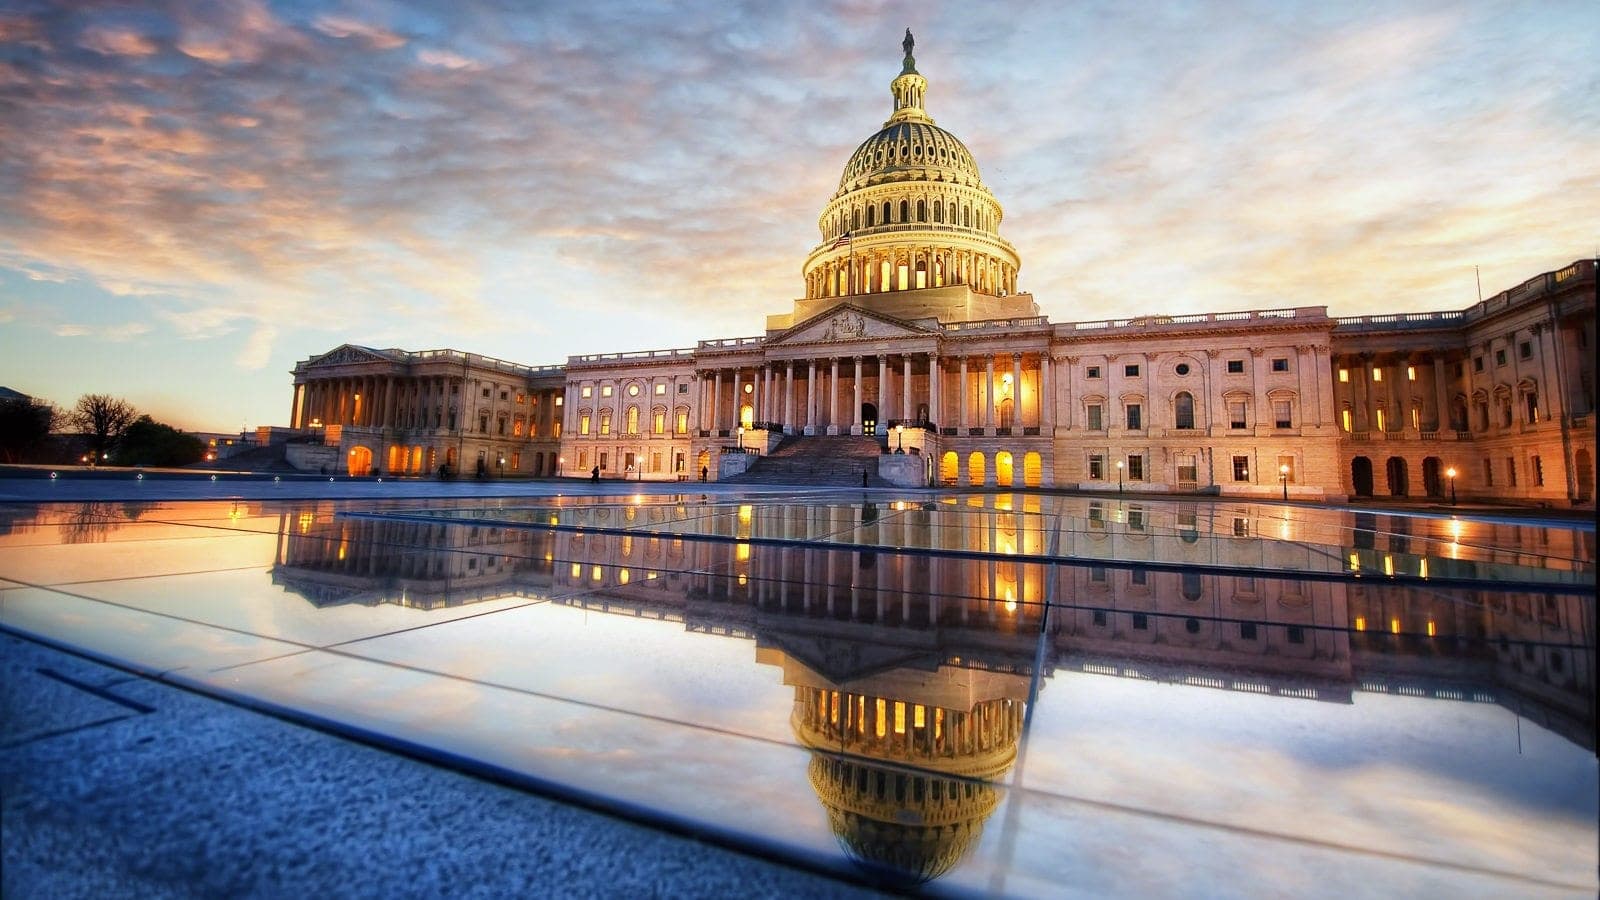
[699,352,1054,431]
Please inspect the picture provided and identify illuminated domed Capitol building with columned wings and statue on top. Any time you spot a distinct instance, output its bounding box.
[288,34,1597,504]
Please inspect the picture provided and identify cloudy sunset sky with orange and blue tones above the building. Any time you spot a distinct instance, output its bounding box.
[0,0,1600,431]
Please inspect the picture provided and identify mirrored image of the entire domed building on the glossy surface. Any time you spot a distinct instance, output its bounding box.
[274,498,1595,884]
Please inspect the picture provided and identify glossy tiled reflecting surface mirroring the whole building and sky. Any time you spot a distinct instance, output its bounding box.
[0,493,1600,895]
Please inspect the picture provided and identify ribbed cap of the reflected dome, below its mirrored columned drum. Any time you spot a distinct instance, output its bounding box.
[810,753,998,887]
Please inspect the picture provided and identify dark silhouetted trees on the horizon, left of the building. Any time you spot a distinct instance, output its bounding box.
[0,394,205,466]
